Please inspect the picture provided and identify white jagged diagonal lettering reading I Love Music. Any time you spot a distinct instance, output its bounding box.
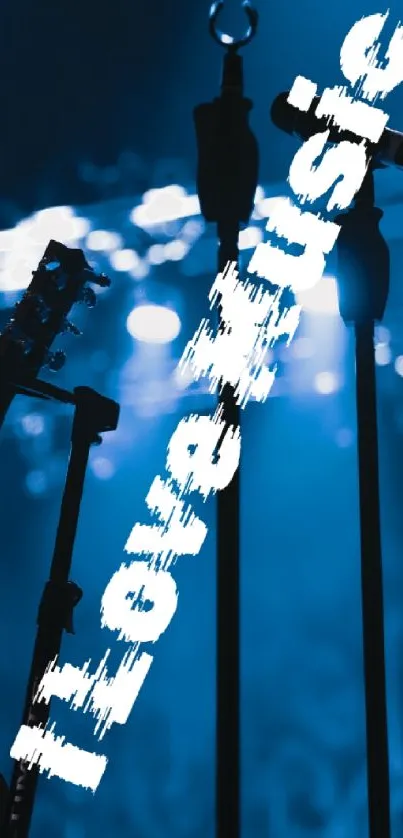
[11,13,403,791]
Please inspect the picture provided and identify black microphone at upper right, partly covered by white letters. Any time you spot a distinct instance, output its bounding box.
[270,93,403,168]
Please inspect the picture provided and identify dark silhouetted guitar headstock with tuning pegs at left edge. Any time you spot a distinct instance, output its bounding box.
[0,239,110,383]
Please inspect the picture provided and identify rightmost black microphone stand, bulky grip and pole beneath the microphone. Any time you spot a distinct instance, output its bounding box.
[336,166,391,838]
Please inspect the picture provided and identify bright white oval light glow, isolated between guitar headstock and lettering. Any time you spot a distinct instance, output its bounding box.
[126,305,181,343]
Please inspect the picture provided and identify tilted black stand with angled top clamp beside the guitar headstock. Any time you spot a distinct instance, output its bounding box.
[1,381,119,838]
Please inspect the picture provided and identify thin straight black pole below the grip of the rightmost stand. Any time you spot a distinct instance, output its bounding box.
[355,323,390,838]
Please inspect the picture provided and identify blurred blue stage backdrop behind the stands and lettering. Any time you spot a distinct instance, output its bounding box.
[0,0,403,838]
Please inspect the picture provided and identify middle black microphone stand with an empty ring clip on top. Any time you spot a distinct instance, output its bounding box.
[194,2,258,838]
